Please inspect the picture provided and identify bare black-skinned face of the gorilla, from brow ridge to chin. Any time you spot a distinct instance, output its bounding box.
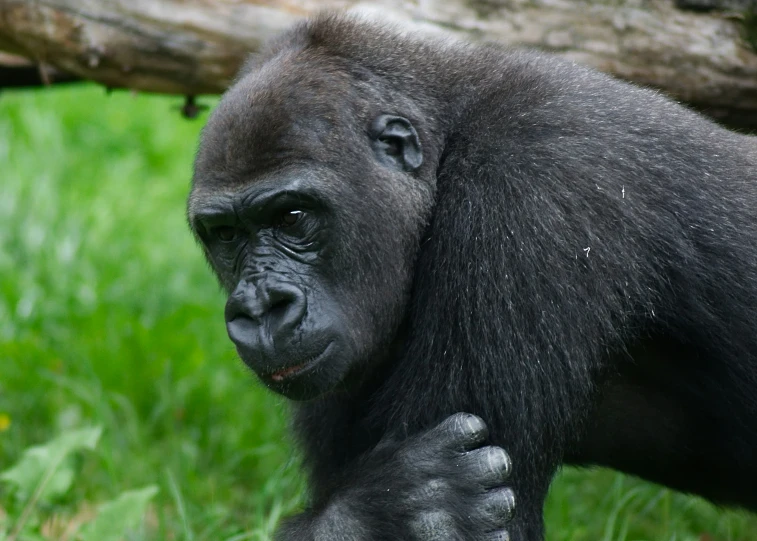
[192,167,361,399]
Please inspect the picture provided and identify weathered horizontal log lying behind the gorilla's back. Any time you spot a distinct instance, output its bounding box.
[0,0,757,125]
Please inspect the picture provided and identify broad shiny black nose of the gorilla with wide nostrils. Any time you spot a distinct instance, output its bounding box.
[226,281,307,350]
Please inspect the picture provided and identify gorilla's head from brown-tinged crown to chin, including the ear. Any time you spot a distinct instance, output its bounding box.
[189,59,433,400]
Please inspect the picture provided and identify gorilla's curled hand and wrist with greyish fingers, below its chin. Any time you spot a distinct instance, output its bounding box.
[279,413,515,541]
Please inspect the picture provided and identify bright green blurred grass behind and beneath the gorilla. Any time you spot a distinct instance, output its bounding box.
[0,86,757,541]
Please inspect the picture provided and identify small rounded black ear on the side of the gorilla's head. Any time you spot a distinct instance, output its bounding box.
[369,115,423,173]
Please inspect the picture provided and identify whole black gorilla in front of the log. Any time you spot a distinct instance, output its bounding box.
[189,15,757,541]
